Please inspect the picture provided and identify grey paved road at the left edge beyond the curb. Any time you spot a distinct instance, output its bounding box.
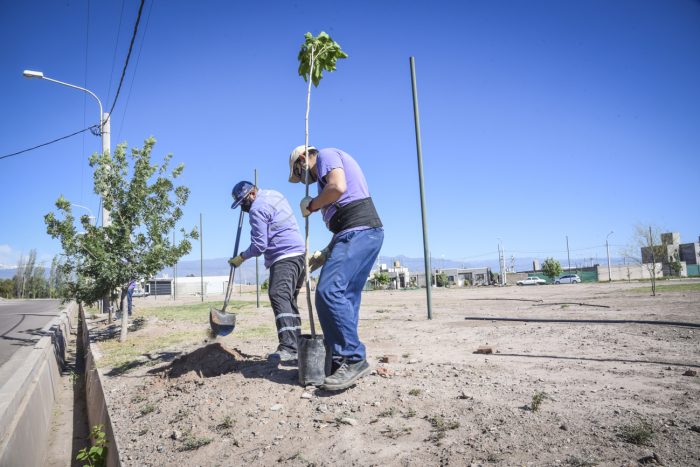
[0,300,60,365]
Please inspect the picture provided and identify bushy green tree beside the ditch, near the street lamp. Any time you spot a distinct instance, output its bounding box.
[44,138,198,342]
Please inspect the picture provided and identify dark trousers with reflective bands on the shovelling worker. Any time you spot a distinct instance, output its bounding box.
[268,255,304,352]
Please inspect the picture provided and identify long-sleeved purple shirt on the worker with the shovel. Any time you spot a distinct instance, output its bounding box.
[241,190,305,268]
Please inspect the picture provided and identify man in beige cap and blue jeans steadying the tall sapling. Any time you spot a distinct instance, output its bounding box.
[289,146,384,391]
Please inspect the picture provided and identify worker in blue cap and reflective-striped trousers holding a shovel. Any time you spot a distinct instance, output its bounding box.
[229,181,305,362]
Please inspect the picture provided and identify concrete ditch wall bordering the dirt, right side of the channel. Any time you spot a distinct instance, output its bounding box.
[80,308,121,467]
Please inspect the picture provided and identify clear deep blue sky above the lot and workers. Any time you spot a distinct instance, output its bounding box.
[0,0,700,265]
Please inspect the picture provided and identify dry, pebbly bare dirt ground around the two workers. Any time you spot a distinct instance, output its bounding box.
[94,283,700,466]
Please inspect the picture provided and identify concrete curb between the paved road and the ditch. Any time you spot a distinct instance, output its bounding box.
[0,303,75,467]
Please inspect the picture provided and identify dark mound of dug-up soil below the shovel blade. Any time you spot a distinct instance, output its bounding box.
[162,343,244,378]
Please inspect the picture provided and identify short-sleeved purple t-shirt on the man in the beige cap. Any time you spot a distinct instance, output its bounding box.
[316,148,369,230]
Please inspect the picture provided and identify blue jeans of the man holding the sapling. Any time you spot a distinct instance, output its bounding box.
[316,228,384,363]
